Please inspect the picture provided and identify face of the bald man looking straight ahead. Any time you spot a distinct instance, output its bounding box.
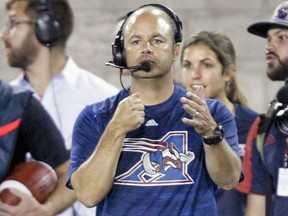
[124,8,179,78]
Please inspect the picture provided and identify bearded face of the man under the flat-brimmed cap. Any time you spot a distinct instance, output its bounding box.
[266,28,288,81]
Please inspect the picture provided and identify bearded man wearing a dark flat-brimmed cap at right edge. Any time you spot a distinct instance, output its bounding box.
[238,1,288,216]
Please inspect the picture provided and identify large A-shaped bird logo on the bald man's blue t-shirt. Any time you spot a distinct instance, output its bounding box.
[114,131,195,186]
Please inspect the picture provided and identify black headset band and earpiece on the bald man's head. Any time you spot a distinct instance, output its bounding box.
[110,4,183,67]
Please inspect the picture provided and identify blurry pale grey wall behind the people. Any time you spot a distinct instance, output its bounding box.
[0,0,283,112]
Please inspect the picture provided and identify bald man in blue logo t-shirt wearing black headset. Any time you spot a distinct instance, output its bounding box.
[67,4,241,216]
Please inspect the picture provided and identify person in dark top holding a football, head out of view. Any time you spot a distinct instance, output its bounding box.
[0,81,76,216]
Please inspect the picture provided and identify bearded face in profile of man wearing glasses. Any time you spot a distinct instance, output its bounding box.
[2,1,37,69]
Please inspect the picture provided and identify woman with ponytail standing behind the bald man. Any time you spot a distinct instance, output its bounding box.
[180,31,258,216]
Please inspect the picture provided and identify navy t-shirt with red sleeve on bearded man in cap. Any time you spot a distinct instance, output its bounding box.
[240,122,288,216]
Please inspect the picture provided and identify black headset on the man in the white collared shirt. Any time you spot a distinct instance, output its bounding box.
[35,0,61,46]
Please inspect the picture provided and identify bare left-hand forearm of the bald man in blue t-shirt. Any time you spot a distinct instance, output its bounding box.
[71,121,125,207]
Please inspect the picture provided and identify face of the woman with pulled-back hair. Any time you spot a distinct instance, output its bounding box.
[181,43,230,100]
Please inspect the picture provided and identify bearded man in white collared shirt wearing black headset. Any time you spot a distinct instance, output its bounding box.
[2,0,118,216]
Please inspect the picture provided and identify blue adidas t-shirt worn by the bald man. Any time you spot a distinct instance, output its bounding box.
[67,86,239,216]
